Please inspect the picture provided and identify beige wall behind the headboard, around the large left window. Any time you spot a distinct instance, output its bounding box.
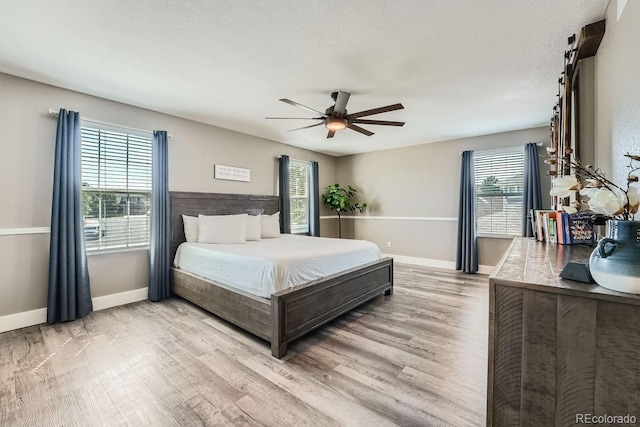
[0,73,337,316]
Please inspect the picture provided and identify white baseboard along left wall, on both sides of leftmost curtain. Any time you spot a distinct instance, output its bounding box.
[0,288,149,333]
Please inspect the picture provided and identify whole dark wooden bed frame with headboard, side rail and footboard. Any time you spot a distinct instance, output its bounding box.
[170,192,393,359]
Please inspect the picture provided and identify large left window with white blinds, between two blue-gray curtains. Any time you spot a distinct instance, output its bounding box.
[81,125,152,251]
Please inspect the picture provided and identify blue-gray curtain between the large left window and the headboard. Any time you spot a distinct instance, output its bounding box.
[149,130,171,301]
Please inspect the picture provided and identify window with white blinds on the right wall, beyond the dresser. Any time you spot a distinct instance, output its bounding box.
[473,147,524,236]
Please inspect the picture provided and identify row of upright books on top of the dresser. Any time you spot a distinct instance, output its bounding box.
[530,209,596,245]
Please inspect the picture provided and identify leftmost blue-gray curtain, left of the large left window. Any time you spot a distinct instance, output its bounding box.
[47,109,93,324]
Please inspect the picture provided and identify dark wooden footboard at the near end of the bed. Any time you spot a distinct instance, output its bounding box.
[271,258,393,359]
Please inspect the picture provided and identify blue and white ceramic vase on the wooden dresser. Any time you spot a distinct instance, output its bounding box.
[589,220,640,294]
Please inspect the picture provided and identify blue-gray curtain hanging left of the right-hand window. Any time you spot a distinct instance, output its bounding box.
[456,151,478,273]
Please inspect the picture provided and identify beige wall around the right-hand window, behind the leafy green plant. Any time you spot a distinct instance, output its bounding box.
[338,127,551,266]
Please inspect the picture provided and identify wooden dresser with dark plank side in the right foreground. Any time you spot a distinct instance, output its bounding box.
[487,238,640,426]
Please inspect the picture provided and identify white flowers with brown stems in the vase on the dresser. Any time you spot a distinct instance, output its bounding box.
[549,154,640,220]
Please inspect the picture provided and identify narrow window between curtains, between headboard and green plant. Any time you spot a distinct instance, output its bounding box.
[289,160,311,233]
